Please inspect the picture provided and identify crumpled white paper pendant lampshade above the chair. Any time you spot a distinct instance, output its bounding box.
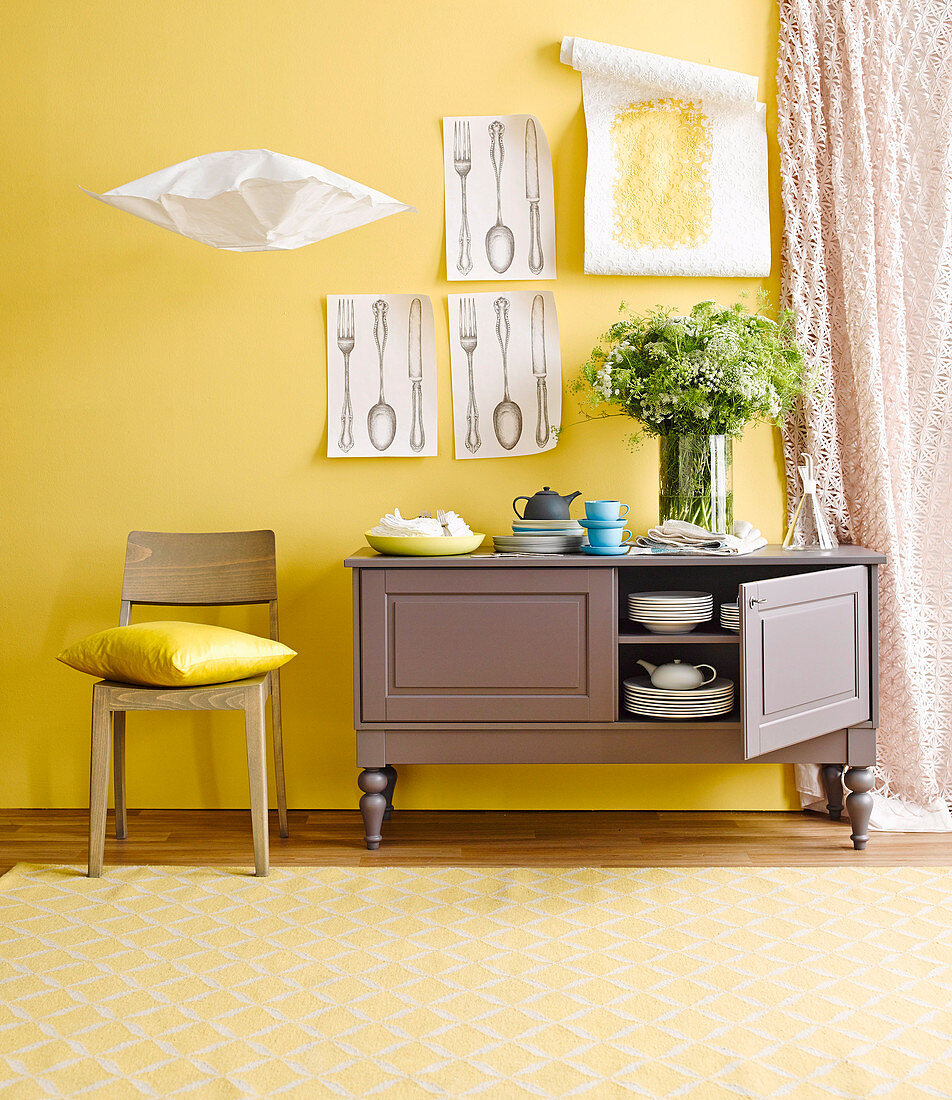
[83,149,416,252]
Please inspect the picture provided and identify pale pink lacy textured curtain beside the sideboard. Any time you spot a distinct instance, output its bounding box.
[778,0,952,805]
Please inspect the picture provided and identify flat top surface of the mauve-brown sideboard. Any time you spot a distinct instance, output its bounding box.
[343,546,886,569]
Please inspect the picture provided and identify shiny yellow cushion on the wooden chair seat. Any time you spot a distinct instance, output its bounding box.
[56,623,296,688]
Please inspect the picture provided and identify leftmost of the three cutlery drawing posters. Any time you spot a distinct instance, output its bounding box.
[327,294,437,459]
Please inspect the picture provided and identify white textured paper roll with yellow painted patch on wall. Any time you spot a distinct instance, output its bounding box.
[561,37,770,276]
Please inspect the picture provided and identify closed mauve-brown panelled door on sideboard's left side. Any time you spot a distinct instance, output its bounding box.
[361,568,615,723]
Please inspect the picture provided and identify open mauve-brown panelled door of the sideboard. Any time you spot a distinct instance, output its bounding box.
[737,565,869,759]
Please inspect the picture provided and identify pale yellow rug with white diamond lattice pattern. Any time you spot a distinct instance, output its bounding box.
[0,865,952,1100]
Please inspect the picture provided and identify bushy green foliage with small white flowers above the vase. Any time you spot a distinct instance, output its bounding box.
[570,297,808,440]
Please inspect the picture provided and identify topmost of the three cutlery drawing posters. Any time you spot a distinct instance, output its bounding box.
[442,114,556,281]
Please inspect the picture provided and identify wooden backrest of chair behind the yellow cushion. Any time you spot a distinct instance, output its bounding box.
[122,531,277,622]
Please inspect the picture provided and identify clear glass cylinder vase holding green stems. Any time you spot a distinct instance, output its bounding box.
[658,433,734,534]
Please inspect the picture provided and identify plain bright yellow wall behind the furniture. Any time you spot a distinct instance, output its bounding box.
[0,0,792,809]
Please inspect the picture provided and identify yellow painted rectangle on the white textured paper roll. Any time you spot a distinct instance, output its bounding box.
[612,99,712,249]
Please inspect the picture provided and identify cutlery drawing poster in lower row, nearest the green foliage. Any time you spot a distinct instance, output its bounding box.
[449,290,562,459]
